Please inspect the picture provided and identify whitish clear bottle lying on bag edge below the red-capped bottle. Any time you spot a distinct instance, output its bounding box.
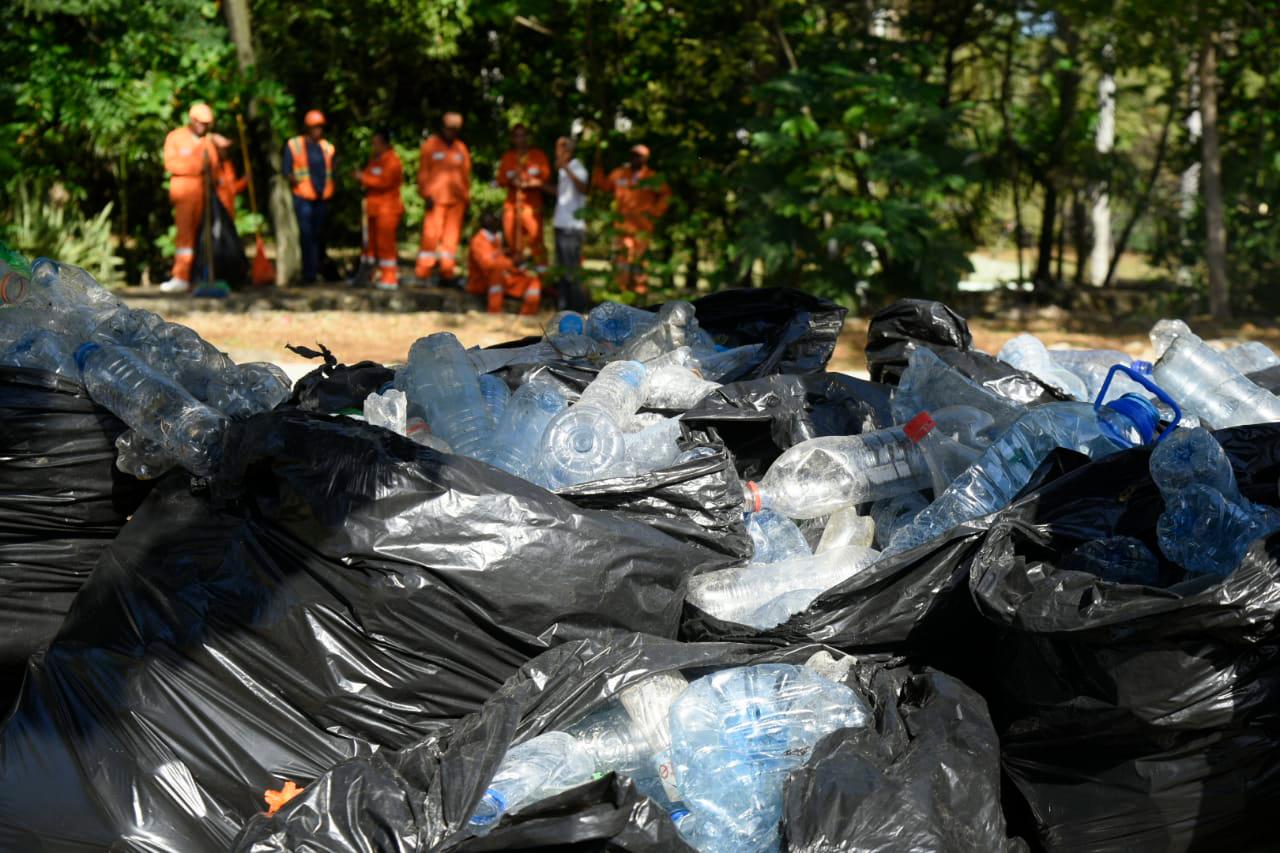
[685,546,879,622]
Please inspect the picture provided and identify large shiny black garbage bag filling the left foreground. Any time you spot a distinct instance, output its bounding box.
[0,410,728,852]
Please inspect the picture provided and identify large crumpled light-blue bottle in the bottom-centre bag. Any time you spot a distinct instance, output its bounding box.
[671,663,870,853]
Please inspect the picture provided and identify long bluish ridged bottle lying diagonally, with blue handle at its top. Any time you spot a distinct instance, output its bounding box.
[886,394,1160,553]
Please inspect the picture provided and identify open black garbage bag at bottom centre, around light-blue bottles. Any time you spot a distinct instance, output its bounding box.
[236,635,1006,853]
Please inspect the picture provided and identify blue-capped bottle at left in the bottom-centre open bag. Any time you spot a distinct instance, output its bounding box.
[470,731,595,831]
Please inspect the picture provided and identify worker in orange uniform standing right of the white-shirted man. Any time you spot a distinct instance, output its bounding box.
[591,145,671,293]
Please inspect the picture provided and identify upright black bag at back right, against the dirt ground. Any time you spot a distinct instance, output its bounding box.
[867,300,1069,405]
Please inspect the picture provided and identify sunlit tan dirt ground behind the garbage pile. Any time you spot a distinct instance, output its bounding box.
[174,302,1280,374]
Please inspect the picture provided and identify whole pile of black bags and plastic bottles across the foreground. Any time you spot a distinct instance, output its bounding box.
[0,247,1280,853]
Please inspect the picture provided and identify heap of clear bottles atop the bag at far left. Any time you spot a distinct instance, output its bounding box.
[0,256,292,478]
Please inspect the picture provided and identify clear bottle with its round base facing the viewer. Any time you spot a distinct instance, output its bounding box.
[543,361,646,488]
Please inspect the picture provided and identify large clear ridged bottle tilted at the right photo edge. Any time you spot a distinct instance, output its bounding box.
[1152,336,1280,429]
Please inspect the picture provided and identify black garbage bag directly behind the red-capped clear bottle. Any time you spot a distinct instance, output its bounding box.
[681,373,892,479]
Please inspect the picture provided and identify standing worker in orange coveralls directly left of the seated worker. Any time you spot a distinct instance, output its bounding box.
[413,113,471,279]
